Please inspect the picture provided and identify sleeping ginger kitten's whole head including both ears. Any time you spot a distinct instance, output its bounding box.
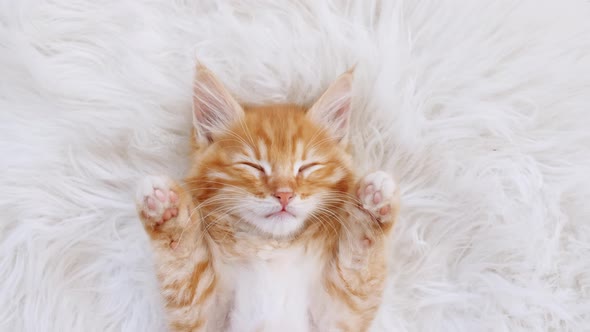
[195,64,353,237]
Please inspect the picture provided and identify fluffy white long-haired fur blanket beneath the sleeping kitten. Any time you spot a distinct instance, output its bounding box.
[0,0,590,332]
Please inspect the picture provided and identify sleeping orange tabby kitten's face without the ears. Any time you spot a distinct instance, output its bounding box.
[200,107,352,236]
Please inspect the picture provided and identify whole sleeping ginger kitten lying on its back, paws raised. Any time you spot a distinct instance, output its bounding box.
[136,65,398,332]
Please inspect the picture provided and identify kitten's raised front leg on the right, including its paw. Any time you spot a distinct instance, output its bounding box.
[322,171,399,331]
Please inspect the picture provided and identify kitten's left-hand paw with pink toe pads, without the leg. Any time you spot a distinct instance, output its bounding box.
[135,176,179,229]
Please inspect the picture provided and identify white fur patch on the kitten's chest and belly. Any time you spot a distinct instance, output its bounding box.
[228,244,321,332]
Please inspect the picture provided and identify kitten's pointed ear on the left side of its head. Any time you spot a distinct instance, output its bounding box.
[193,63,244,143]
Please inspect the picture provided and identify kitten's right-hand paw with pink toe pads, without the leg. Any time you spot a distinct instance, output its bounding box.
[356,171,397,222]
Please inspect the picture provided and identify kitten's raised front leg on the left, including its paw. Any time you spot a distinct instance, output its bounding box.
[136,176,216,331]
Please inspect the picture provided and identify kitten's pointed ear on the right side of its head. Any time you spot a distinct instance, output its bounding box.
[308,68,354,141]
